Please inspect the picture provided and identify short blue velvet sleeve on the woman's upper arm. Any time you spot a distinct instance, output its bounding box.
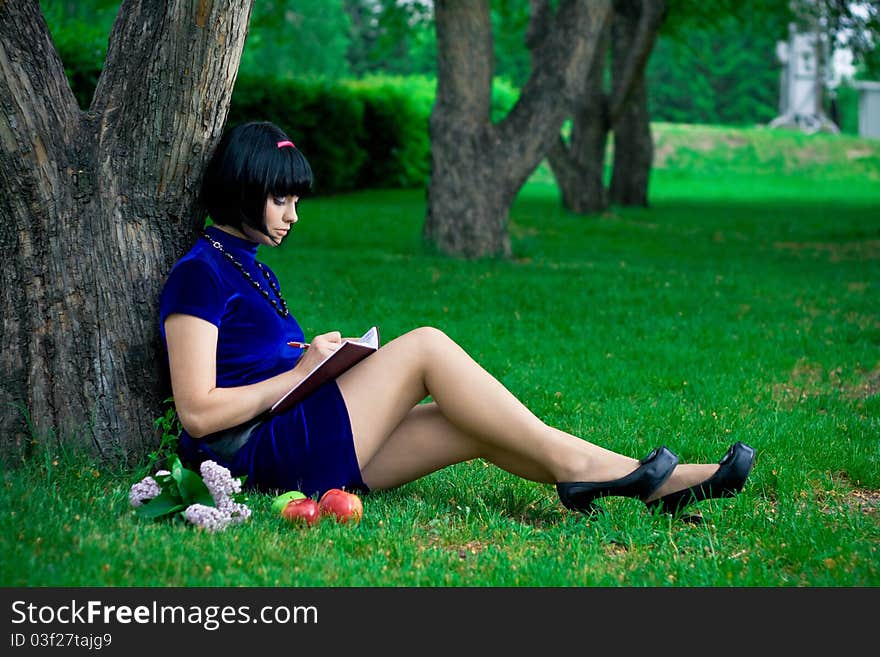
[159,258,226,335]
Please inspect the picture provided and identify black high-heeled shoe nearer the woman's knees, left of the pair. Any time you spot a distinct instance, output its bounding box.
[556,447,678,514]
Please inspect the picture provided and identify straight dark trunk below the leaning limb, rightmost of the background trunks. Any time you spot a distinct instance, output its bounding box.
[609,73,654,207]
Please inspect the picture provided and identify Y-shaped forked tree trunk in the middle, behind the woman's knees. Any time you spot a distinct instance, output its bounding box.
[424,0,610,257]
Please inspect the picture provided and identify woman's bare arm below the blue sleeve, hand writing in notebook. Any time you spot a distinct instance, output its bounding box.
[165,313,341,438]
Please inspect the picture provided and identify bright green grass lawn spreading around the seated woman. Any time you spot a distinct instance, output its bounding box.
[0,125,880,587]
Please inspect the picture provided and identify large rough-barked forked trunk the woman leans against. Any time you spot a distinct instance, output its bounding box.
[0,0,252,460]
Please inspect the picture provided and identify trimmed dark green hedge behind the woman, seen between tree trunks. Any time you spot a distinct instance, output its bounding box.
[46,24,519,194]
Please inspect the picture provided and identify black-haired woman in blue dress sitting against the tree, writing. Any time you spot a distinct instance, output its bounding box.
[160,122,755,513]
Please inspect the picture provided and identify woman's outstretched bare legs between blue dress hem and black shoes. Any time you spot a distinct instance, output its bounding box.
[338,328,717,497]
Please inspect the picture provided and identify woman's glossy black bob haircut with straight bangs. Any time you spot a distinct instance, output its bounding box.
[200,121,312,234]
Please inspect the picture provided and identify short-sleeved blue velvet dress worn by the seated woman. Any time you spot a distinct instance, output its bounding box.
[159,226,367,496]
